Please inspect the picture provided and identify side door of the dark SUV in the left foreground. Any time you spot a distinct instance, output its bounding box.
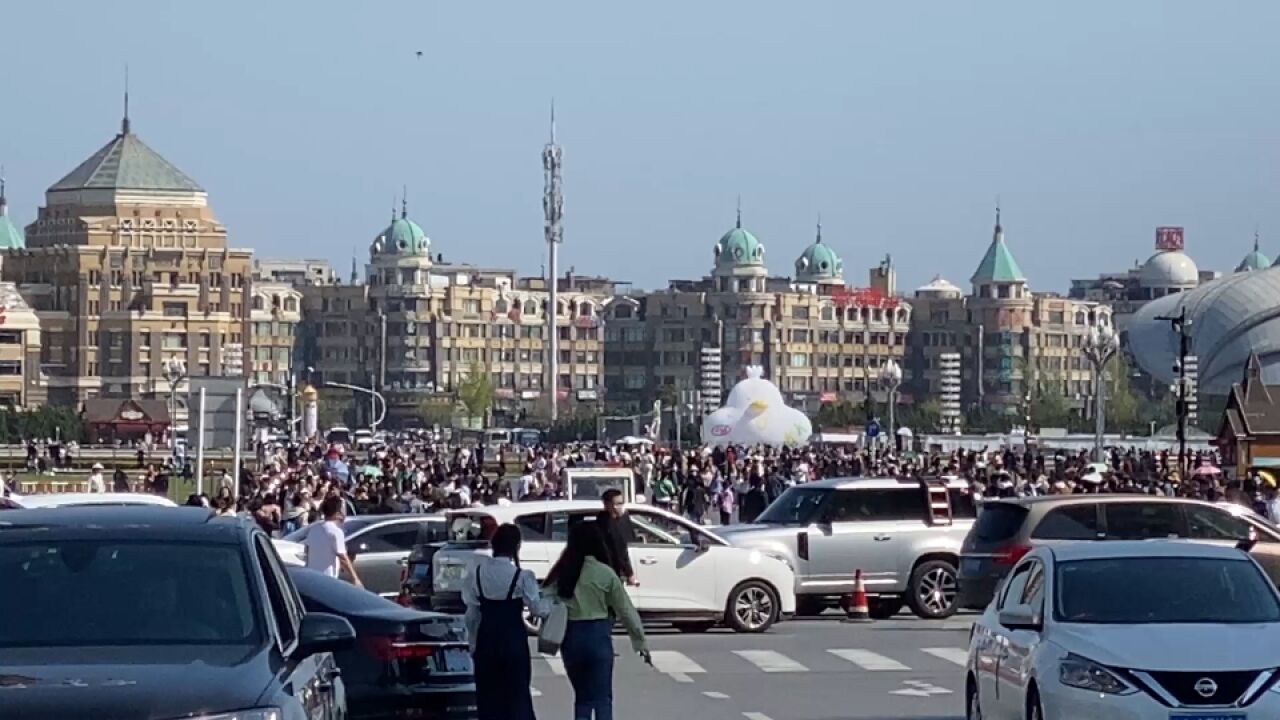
[253,536,335,720]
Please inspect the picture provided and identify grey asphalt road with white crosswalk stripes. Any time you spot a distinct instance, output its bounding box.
[532,614,972,720]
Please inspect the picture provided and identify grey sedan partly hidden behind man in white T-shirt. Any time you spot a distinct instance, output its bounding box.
[284,512,444,597]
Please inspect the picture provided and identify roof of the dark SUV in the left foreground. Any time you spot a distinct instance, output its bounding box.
[0,505,256,544]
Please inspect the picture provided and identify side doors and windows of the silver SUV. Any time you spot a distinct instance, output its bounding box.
[809,486,925,593]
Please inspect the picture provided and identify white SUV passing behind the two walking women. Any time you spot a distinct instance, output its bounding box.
[431,501,796,633]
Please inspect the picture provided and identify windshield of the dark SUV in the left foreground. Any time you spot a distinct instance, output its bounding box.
[0,539,262,648]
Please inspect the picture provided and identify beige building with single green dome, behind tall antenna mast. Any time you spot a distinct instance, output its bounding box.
[302,209,613,424]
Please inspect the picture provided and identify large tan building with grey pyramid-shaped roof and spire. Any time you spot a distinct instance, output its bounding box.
[3,118,252,419]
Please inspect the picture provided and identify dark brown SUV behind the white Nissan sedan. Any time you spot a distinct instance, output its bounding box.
[959,495,1280,610]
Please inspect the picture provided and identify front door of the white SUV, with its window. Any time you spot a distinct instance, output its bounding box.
[627,510,728,612]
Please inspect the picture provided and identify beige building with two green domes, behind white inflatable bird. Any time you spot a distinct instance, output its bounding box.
[605,217,913,413]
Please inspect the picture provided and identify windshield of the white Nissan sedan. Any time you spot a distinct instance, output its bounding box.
[1055,557,1280,625]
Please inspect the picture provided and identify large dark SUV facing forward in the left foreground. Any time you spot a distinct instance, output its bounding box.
[0,506,356,720]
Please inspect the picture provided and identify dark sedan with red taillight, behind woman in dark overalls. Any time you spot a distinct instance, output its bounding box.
[289,568,476,720]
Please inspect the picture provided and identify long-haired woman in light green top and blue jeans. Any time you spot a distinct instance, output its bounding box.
[545,523,653,720]
